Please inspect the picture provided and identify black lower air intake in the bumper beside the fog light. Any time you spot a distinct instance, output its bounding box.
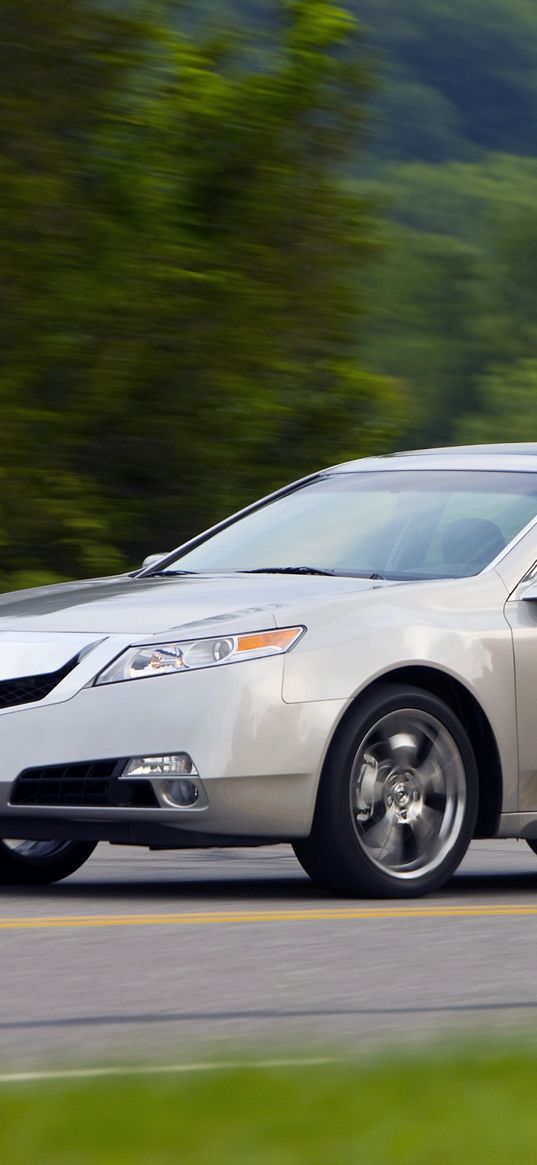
[10,760,158,809]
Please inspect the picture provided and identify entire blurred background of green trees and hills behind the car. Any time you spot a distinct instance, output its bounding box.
[0,0,537,586]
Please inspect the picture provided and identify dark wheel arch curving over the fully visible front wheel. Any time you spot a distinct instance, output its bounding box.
[323,664,503,838]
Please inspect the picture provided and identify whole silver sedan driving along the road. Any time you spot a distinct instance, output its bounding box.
[0,445,537,897]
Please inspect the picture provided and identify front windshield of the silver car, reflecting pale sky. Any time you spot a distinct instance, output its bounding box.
[159,469,537,579]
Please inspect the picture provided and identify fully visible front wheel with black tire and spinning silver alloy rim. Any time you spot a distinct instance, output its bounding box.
[294,684,479,898]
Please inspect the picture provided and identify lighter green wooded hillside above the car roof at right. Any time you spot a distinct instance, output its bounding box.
[366,156,537,446]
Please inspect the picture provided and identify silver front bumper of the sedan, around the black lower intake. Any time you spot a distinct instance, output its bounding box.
[0,658,342,847]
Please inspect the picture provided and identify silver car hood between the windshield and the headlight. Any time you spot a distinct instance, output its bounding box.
[0,574,390,638]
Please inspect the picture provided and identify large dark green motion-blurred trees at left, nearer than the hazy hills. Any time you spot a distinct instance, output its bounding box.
[0,0,398,584]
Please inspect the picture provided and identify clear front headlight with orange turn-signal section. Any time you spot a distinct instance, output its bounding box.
[94,627,305,684]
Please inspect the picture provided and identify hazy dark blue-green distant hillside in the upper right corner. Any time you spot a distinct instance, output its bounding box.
[224,0,537,162]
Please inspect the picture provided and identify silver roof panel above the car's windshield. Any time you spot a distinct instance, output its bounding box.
[332,442,537,473]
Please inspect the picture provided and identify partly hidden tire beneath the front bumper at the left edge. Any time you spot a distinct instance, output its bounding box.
[0,839,97,885]
